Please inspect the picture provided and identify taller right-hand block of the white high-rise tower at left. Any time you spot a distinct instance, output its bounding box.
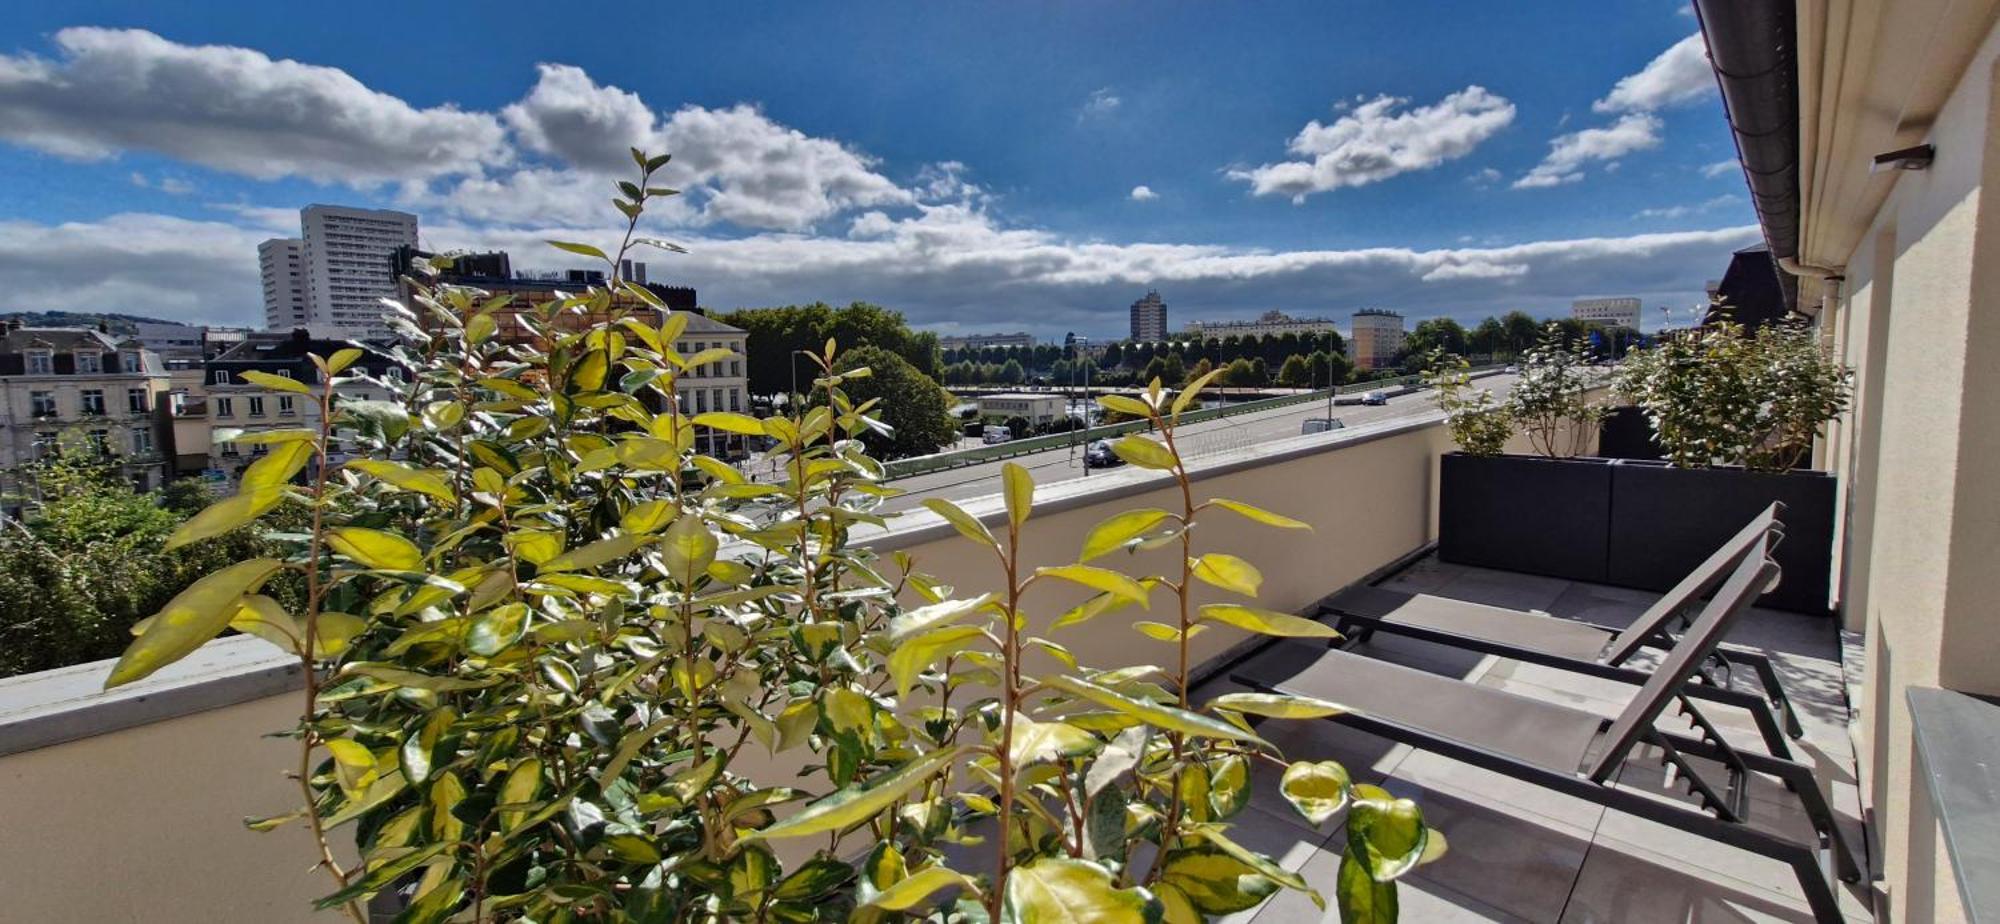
[298,206,416,336]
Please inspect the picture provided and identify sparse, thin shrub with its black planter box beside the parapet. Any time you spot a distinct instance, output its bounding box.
[1426,340,1612,582]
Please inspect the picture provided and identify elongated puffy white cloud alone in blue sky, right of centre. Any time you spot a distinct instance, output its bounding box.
[1228,86,1514,202]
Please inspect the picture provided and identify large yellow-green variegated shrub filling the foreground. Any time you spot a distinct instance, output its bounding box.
[110,150,1442,924]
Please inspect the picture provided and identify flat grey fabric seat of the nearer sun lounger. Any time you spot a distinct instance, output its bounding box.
[1238,640,1604,774]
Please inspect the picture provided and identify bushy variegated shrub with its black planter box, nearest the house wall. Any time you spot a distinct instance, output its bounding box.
[1608,322,1850,612]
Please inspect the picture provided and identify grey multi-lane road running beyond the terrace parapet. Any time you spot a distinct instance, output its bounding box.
[884,374,1516,510]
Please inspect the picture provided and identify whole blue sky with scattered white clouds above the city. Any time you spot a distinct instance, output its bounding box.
[0,0,1756,336]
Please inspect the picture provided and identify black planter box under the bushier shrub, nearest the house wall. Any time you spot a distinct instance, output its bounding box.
[1606,462,1834,614]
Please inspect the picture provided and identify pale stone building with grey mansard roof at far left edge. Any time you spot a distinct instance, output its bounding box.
[0,322,168,512]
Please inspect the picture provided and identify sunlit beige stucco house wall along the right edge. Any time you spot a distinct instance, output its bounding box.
[1836,16,2000,922]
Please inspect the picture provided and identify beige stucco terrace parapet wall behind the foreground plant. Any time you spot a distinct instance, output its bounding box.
[0,422,1448,924]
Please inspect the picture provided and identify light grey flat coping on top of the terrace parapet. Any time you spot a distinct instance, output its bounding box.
[0,412,1444,758]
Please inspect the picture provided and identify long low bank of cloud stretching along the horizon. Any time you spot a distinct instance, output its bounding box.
[0,202,1758,336]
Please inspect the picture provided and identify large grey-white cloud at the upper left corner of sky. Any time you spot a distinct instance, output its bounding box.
[0,28,508,186]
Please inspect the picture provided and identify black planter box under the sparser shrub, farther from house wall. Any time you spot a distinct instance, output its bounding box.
[1438,452,1608,584]
